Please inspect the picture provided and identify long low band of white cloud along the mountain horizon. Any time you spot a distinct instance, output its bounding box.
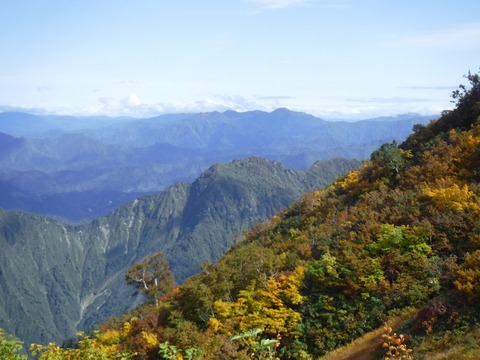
[0,90,451,120]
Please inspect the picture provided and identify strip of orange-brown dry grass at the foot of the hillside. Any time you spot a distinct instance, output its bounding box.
[320,310,417,360]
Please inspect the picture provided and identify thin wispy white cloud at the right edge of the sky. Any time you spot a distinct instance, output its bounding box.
[405,22,480,49]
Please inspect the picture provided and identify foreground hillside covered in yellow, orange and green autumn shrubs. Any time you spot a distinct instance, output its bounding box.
[16,69,480,359]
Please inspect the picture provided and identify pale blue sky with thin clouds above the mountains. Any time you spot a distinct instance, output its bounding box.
[0,0,480,119]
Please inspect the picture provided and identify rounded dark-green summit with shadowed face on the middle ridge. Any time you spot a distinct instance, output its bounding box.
[172,158,316,278]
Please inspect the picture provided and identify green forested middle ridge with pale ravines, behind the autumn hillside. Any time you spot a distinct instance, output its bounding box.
[0,158,359,343]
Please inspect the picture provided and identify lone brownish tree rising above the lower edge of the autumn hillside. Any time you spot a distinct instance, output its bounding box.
[125,252,175,304]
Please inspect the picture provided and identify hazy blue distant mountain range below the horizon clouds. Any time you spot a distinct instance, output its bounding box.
[0,109,434,221]
